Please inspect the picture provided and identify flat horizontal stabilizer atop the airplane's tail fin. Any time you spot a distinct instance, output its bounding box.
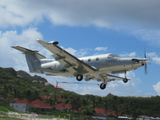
[12,46,46,59]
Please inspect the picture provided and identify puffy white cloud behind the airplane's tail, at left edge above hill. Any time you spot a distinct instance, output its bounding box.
[0,28,47,70]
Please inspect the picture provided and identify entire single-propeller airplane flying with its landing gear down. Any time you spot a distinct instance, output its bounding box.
[12,40,150,89]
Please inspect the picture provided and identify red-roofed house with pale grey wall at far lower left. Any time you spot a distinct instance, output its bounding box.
[10,99,52,112]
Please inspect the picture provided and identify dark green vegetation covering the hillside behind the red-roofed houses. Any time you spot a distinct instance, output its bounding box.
[0,68,160,117]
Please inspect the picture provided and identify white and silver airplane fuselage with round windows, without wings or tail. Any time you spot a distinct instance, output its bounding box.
[41,54,146,77]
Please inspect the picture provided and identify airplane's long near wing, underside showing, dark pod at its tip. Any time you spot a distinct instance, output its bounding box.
[37,40,96,75]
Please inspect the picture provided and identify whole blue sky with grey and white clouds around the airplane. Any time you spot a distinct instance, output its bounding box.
[0,0,160,97]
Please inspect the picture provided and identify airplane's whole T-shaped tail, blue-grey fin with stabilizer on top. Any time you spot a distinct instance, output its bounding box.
[12,46,45,73]
